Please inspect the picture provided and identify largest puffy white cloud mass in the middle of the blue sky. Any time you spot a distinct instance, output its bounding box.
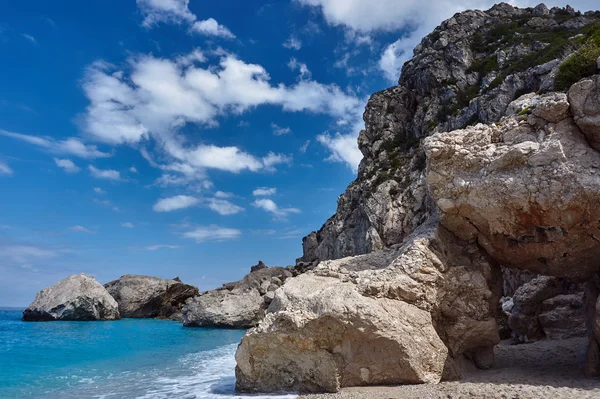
[82,54,361,184]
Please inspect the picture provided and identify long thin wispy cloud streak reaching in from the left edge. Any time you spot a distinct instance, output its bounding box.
[0,129,112,159]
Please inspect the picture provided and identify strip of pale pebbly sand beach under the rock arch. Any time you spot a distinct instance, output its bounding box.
[301,338,600,399]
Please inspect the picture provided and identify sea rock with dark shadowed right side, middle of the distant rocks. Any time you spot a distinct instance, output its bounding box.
[104,274,199,320]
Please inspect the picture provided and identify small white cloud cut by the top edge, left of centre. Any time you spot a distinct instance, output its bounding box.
[137,0,196,28]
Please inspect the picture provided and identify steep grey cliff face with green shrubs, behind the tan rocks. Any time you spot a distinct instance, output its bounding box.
[298,4,600,266]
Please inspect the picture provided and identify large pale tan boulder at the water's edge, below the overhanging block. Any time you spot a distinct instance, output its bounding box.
[236,222,501,392]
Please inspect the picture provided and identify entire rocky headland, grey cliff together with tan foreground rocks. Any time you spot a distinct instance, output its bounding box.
[236,4,600,392]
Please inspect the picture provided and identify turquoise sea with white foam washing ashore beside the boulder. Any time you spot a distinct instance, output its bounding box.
[0,309,296,399]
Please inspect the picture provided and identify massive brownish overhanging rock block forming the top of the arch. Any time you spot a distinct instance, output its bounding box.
[424,93,600,281]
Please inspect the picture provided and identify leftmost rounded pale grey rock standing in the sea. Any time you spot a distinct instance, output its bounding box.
[23,274,120,321]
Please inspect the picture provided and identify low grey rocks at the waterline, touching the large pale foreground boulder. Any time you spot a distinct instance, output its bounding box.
[182,262,292,328]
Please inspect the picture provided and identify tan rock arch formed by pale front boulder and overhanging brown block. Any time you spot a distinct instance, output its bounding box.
[236,77,600,392]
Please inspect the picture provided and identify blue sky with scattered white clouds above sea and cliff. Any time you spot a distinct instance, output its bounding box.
[0,0,593,306]
